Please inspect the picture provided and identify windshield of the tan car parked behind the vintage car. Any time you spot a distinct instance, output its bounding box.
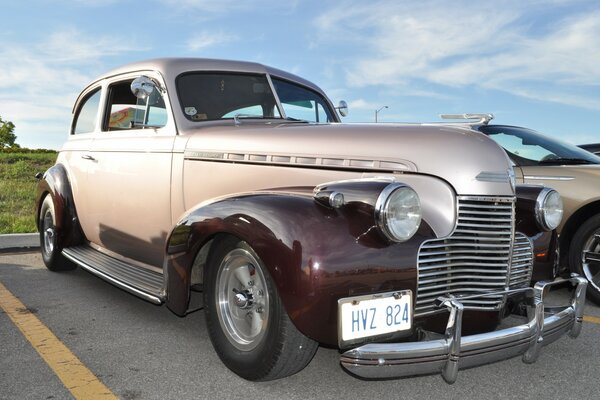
[479,125,600,165]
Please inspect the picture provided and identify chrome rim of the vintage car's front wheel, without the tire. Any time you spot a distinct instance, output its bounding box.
[216,249,269,351]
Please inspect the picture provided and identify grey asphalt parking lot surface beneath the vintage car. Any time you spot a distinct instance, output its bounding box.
[0,253,600,400]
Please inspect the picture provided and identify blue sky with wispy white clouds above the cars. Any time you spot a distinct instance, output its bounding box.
[0,0,600,149]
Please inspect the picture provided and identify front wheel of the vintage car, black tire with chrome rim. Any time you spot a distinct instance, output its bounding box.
[204,236,318,381]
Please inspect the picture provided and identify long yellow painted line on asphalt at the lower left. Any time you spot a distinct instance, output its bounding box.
[0,283,117,399]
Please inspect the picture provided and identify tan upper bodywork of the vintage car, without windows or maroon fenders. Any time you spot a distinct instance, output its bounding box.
[59,59,514,267]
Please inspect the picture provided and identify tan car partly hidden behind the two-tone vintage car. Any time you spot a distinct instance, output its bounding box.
[442,114,600,304]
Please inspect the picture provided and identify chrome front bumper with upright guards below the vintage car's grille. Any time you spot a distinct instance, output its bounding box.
[341,275,587,383]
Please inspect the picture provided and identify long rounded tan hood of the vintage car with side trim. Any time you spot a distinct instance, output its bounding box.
[181,121,514,196]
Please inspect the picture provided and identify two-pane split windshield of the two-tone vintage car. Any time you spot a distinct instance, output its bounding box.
[177,72,333,123]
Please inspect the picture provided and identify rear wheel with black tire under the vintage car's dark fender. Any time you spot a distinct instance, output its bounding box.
[38,195,76,271]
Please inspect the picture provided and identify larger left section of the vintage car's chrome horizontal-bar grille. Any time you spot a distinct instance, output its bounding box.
[415,196,514,315]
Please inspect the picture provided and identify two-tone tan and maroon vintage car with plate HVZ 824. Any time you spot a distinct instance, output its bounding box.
[37,59,587,382]
